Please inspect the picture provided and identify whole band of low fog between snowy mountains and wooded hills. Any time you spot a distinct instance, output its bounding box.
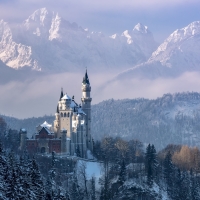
[0,70,200,118]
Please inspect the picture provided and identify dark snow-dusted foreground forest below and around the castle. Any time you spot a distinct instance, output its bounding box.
[0,118,200,200]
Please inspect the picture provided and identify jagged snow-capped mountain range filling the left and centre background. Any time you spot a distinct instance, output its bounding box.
[0,8,157,71]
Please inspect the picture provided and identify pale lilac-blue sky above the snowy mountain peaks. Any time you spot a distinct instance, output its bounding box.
[0,0,200,43]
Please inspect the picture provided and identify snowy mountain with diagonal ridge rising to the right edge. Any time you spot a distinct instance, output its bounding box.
[117,21,200,79]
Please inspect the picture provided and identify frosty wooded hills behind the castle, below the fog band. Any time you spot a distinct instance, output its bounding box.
[2,92,200,149]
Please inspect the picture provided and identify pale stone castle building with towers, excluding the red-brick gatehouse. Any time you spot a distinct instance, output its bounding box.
[53,70,92,157]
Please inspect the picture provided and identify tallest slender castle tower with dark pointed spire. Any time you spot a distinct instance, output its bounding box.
[81,70,92,151]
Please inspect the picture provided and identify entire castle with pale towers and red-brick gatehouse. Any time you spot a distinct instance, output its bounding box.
[20,70,93,158]
